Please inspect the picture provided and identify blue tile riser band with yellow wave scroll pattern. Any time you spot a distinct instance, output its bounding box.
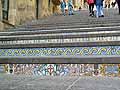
[0,46,120,57]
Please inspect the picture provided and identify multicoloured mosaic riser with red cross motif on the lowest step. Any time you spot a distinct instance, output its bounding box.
[0,64,120,76]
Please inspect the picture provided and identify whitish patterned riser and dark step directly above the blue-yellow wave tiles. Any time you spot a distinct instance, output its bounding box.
[0,37,120,49]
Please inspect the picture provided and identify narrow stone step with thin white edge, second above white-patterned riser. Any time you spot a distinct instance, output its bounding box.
[0,24,120,37]
